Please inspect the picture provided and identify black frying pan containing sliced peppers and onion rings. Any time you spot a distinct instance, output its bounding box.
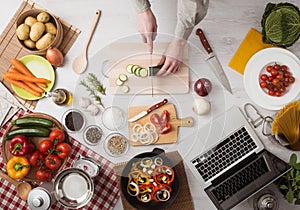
[120,148,180,210]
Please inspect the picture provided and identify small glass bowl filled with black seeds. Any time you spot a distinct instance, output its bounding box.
[62,109,85,133]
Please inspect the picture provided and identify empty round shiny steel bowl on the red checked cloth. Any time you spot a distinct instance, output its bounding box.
[54,168,94,209]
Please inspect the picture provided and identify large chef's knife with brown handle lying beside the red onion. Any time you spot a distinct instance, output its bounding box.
[196,28,232,93]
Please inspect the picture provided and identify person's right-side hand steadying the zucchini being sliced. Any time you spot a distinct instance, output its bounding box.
[156,39,186,76]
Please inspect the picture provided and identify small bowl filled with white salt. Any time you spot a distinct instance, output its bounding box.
[101,106,126,131]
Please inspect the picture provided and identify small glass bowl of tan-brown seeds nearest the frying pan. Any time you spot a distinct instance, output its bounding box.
[104,133,129,157]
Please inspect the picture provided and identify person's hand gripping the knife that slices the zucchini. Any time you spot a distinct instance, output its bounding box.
[137,9,157,54]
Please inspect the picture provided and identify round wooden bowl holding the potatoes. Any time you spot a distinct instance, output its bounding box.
[16,9,63,55]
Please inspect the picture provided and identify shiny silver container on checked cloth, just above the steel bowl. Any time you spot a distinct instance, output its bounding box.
[72,155,101,178]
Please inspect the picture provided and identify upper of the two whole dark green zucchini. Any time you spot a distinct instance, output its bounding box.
[11,117,54,128]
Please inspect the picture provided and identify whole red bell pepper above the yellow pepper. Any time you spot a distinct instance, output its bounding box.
[8,136,34,156]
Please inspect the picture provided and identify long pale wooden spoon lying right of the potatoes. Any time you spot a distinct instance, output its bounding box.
[72,10,101,74]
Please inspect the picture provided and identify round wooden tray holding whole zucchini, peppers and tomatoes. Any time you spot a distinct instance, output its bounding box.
[2,112,68,182]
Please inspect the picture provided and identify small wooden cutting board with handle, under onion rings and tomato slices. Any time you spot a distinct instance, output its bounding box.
[128,103,194,146]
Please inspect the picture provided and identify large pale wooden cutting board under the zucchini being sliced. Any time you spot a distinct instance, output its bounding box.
[109,43,189,94]
